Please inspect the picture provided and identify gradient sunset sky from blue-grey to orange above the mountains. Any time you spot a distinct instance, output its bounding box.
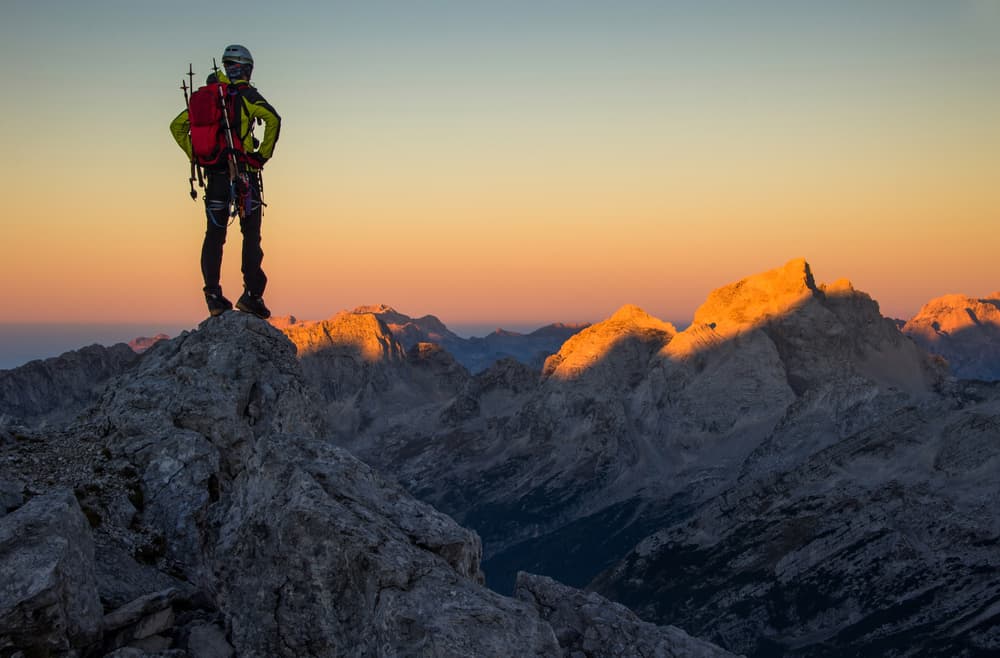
[0,0,1000,326]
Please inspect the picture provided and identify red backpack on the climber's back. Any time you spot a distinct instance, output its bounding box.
[188,82,244,167]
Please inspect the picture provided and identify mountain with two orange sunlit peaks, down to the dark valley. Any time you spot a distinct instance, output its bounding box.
[306,259,943,608]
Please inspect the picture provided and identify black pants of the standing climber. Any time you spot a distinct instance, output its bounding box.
[201,170,267,296]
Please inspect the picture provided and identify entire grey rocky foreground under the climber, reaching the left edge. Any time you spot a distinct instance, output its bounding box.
[0,313,731,657]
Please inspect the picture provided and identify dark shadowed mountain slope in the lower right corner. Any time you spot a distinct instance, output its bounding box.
[594,387,1000,656]
